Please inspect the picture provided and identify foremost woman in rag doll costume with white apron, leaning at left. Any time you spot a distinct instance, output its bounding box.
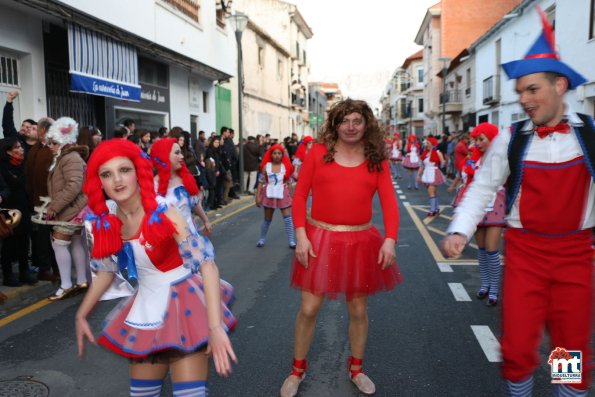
[75,139,237,397]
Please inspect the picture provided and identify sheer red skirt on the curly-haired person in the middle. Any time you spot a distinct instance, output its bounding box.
[291,223,403,300]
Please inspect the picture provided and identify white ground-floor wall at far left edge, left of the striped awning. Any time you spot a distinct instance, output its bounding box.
[0,1,47,124]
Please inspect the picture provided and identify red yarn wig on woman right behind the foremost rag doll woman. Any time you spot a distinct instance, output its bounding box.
[151,138,199,196]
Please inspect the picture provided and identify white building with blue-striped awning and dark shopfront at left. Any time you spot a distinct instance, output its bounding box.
[0,0,236,136]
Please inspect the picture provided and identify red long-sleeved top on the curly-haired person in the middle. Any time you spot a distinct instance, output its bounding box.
[292,144,399,241]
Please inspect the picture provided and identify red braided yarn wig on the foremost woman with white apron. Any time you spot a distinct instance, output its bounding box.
[83,139,176,258]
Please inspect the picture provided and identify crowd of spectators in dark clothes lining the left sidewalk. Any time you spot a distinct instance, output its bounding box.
[0,92,314,295]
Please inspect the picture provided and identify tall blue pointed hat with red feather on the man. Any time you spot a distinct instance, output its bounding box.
[502,6,587,90]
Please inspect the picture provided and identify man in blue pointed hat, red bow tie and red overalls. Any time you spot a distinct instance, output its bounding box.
[442,9,595,396]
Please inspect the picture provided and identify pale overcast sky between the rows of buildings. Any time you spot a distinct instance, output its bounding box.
[287,0,438,107]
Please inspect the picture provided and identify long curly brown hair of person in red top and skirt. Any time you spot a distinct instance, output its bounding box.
[318,98,386,172]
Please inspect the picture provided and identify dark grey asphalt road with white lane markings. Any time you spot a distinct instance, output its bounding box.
[0,180,576,397]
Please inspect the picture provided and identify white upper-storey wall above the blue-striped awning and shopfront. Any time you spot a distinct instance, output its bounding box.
[60,0,236,75]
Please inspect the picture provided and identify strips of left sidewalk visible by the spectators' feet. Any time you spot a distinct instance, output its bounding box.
[0,195,254,312]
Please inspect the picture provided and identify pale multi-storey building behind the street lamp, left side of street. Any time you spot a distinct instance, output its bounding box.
[234,0,312,140]
